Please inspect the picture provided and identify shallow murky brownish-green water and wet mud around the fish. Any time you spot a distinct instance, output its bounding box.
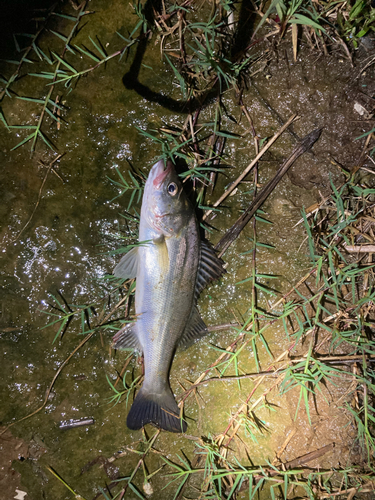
[0,0,375,499]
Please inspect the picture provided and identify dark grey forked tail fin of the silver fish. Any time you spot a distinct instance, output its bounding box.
[126,387,187,432]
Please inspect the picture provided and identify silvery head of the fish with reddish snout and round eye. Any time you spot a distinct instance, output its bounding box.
[141,160,193,237]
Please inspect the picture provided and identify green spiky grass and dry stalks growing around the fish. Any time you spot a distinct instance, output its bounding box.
[0,0,375,500]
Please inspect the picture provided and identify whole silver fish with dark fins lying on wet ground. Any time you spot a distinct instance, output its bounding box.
[113,160,225,432]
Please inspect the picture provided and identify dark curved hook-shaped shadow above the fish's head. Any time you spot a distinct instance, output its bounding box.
[122,0,255,113]
